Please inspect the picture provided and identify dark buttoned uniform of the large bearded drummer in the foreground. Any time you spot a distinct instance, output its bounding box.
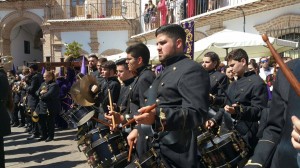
[144,56,210,168]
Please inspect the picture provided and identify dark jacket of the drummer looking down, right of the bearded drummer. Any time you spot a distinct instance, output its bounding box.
[213,72,268,148]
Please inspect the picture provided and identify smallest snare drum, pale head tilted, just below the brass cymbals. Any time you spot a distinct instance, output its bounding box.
[69,107,95,126]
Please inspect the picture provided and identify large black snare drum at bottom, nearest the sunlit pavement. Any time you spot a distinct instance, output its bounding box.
[91,132,128,167]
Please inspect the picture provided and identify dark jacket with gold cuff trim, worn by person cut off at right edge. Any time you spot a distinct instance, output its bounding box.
[246,59,300,168]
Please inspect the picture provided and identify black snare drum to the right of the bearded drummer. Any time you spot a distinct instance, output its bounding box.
[197,132,249,168]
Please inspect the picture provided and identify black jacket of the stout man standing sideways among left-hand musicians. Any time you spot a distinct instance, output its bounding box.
[37,81,61,115]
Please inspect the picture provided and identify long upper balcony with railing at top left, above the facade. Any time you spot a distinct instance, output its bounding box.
[45,0,140,20]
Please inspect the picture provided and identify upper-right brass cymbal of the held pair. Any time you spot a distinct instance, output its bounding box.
[80,75,98,103]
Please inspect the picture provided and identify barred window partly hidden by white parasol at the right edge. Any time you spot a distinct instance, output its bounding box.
[267,27,300,59]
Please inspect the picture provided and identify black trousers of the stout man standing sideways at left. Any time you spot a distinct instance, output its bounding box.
[39,114,55,138]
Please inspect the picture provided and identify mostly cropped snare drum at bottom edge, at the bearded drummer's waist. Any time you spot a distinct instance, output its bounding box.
[126,148,166,168]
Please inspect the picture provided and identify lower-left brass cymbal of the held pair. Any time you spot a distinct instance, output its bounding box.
[70,81,94,106]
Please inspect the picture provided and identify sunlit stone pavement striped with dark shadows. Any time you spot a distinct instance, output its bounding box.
[4,127,89,168]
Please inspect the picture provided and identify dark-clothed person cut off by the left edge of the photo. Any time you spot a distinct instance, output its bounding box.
[0,62,13,168]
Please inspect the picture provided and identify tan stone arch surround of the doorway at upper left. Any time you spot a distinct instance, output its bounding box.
[0,10,43,66]
